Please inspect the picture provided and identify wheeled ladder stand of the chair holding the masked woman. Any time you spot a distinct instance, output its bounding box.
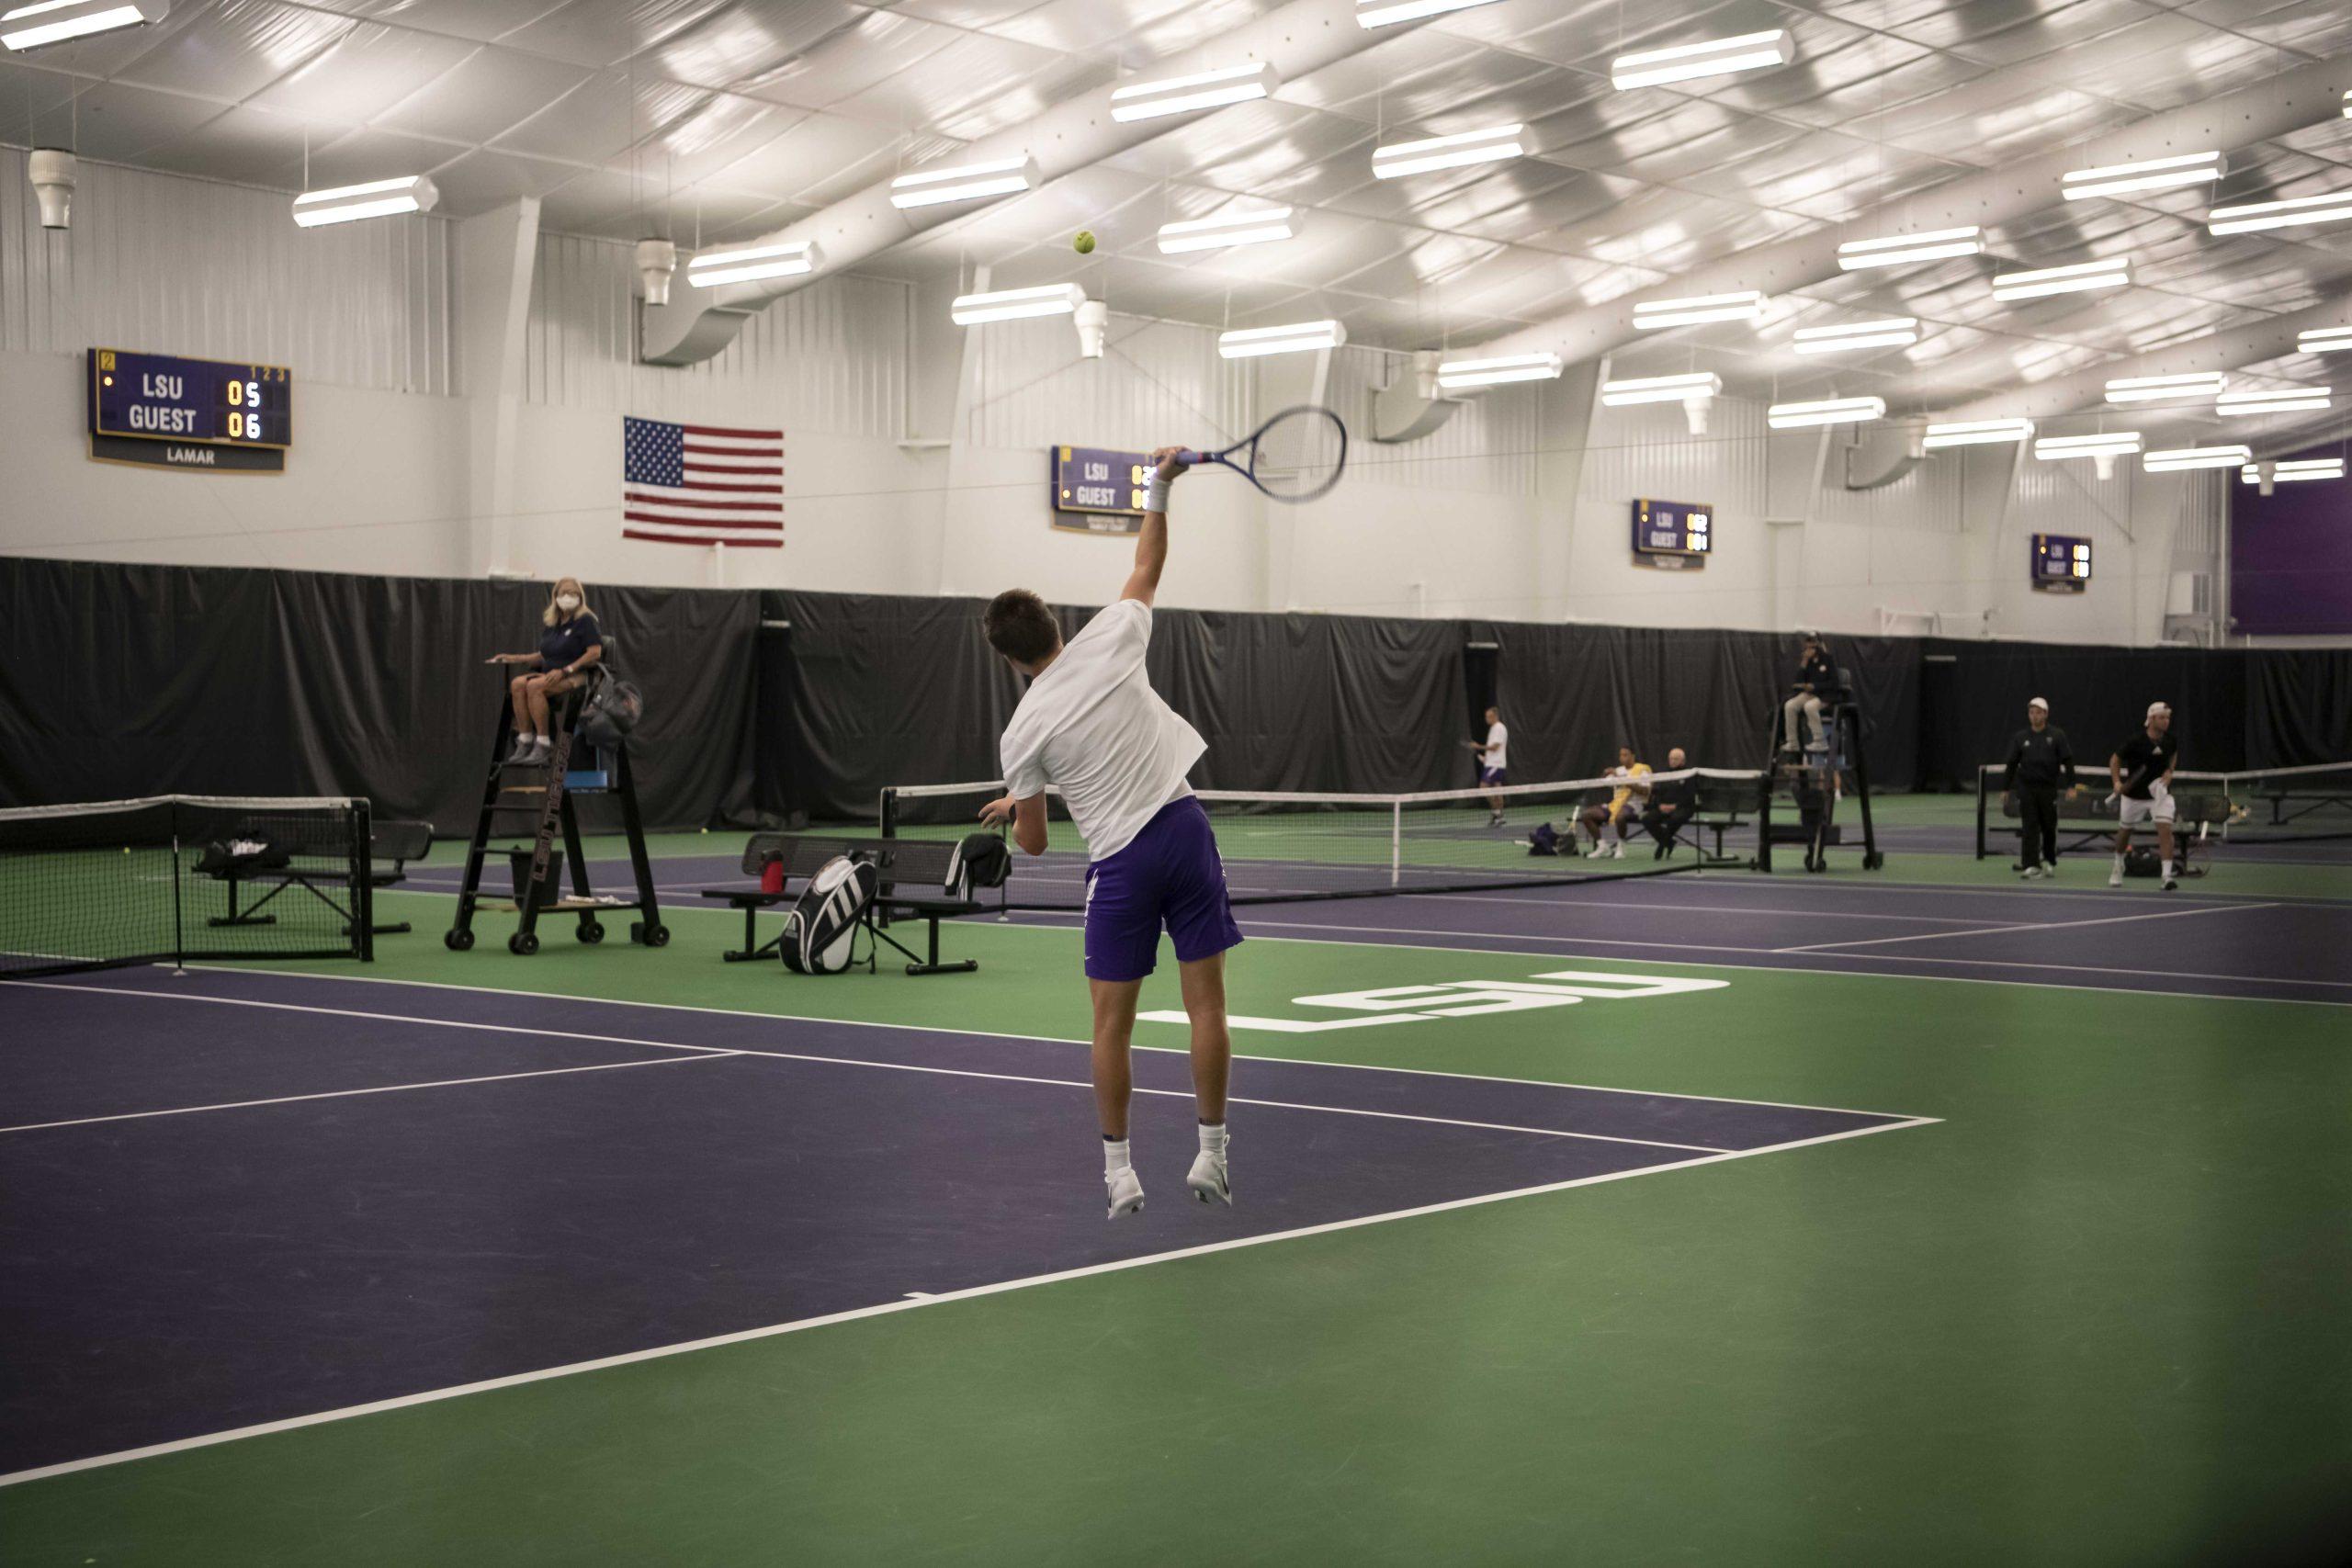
[442,677,671,957]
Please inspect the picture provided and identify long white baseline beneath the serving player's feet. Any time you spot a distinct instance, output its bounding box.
[0,1117,1933,1485]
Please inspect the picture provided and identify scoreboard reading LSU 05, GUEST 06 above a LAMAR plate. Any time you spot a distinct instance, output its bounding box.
[89,348,294,472]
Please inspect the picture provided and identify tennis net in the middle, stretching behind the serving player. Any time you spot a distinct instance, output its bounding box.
[879,769,1764,909]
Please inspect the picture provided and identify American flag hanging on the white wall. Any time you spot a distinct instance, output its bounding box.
[621,416,783,550]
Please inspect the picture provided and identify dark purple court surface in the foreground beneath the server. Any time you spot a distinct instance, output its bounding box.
[0,968,1924,1474]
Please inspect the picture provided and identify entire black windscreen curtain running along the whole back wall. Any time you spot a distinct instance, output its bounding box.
[0,559,2352,832]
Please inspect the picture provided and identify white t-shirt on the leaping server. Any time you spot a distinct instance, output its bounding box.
[1002,600,1209,861]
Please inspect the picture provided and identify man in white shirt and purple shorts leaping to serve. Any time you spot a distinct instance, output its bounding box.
[981,446,1242,1220]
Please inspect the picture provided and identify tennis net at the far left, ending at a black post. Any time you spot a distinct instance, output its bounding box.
[0,795,371,978]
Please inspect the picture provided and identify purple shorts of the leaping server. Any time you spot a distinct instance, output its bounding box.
[1087,795,1242,980]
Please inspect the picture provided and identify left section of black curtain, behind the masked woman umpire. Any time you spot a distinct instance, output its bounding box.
[0,559,760,835]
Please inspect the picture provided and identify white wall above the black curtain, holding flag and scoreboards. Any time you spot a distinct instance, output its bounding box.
[0,151,2221,642]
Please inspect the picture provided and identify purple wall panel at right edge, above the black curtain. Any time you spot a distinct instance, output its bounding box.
[2230,446,2352,635]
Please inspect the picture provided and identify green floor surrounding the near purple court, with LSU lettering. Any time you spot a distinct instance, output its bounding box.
[0,888,2352,1568]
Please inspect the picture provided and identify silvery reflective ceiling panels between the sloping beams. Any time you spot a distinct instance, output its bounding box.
[0,0,2352,434]
